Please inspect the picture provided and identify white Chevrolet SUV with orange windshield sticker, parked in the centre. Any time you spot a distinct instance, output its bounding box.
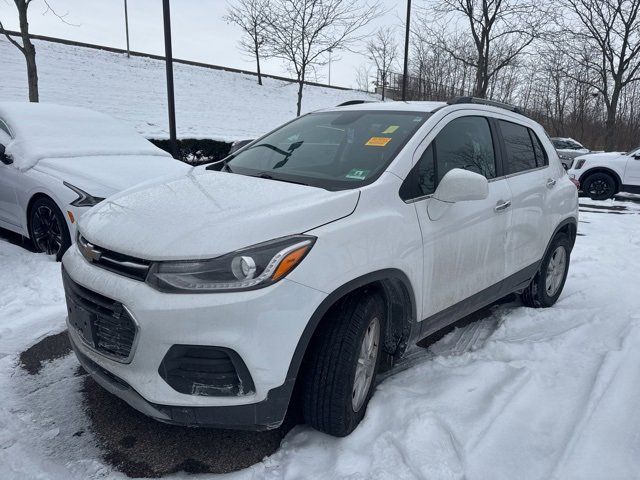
[63,98,578,436]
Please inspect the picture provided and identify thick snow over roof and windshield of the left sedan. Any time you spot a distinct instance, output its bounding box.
[0,102,169,170]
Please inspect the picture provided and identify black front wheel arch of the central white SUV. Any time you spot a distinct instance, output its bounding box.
[287,268,417,386]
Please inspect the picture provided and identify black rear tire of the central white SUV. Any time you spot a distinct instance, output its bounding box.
[521,233,571,308]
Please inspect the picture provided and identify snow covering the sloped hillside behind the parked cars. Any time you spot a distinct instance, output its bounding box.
[0,37,375,141]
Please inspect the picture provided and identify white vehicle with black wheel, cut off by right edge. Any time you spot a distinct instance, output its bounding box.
[567,147,640,200]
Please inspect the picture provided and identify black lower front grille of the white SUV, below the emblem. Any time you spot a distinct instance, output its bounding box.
[62,269,136,361]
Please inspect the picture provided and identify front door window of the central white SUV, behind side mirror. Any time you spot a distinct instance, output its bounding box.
[400,117,496,201]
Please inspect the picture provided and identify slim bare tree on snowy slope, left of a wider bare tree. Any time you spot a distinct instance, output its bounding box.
[224,0,270,85]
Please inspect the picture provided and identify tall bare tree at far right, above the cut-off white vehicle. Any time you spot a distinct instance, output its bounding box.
[562,0,640,150]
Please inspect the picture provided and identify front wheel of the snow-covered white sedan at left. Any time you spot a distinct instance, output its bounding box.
[29,197,71,261]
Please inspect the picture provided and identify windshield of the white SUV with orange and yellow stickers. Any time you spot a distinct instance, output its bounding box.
[227,111,430,190]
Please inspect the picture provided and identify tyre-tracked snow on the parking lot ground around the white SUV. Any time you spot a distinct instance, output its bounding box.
[0,197,640,480]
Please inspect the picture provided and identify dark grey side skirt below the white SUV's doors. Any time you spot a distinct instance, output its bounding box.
[412,259,542,343]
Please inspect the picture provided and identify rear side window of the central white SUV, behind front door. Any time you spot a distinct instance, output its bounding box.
[498,120,547,174]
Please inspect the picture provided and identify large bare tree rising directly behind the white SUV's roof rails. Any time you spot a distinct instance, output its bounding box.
[418,0,549,97]
